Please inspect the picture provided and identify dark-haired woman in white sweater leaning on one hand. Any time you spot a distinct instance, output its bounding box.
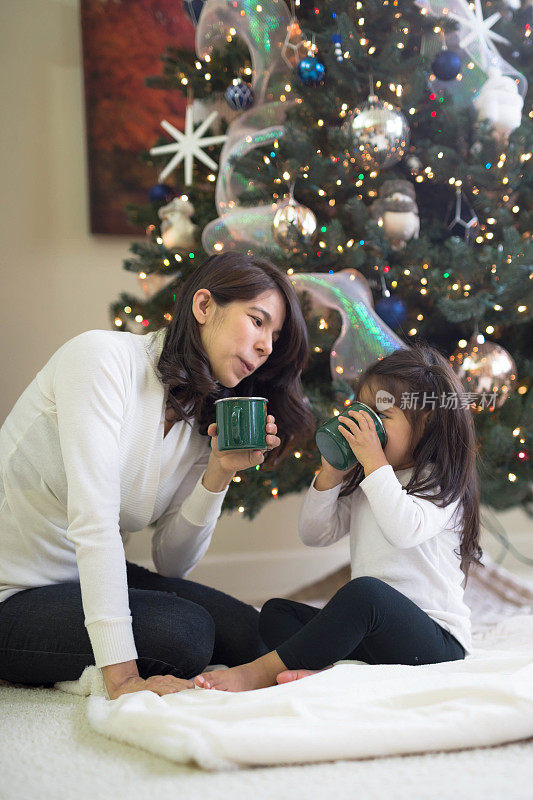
[0,253,311,699]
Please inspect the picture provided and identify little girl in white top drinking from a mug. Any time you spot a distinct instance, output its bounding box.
[195,345,481,691]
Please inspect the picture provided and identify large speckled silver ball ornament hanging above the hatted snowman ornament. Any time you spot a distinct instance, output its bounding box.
[342,95,409,169]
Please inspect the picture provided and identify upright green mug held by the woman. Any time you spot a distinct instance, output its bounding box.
[215,397,268,450]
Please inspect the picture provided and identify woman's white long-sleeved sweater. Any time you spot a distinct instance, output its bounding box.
[0,330,226,667]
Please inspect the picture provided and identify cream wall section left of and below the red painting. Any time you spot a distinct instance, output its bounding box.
[0,0,140,412]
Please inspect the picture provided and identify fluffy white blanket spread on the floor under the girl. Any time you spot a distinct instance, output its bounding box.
[56,562,533,770]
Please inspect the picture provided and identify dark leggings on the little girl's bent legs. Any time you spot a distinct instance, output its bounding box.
[259,577,465,669]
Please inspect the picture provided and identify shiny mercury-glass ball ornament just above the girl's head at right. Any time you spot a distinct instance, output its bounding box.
[450,334,516,411]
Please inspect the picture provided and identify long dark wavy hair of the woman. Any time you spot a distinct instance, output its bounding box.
[157,252,314,462]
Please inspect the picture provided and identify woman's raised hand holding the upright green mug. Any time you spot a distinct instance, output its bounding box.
[202,414,281,492]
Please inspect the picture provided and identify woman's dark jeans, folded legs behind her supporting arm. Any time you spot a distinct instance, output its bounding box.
[0,563,267,686]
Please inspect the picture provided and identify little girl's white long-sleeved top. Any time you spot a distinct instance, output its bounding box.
[299,465,472,654]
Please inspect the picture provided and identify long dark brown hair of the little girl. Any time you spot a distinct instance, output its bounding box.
[341,343,483,577]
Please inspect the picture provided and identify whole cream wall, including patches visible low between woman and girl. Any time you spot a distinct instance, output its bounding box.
[0,0,533,601]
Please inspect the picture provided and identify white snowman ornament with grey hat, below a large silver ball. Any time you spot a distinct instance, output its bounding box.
[370,180,420,249]
